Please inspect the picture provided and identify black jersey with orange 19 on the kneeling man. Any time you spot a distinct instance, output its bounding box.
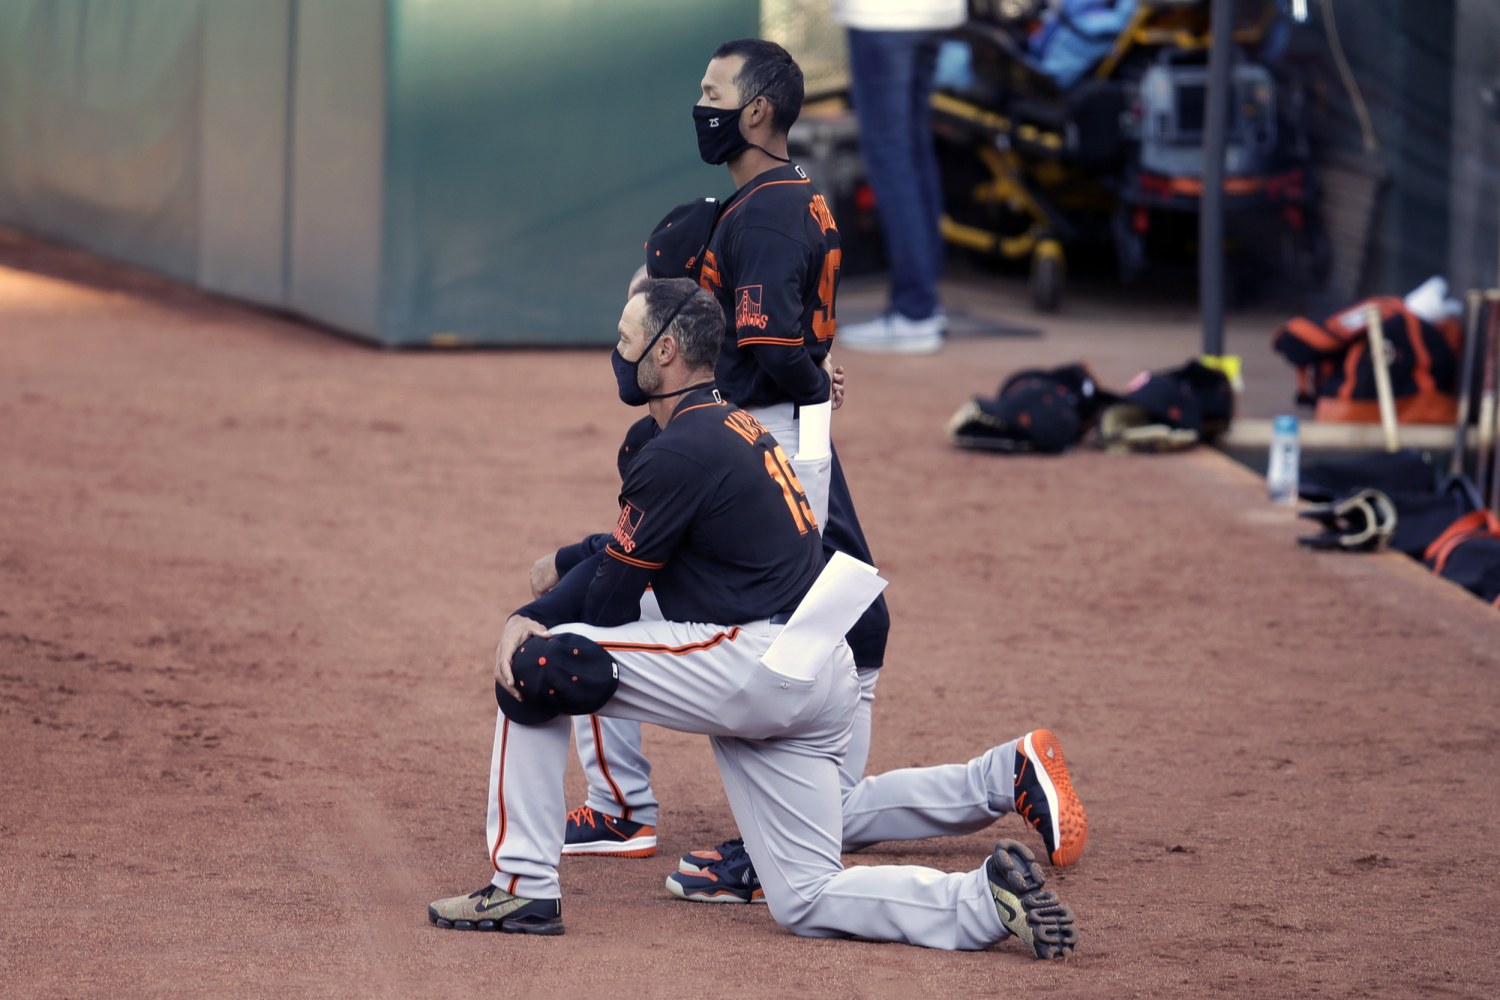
[516,388,824,627]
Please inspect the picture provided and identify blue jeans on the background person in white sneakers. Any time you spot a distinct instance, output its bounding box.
[849,28,944,319]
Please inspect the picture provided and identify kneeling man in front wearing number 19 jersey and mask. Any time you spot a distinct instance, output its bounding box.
[428,280,1077,958]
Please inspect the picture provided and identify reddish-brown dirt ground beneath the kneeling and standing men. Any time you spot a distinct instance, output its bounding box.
[0,234,1500,997]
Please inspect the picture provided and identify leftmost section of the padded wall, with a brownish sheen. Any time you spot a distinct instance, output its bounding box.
[0,0,201,280]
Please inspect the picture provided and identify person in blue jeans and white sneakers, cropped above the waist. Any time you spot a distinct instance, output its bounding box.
[833,0,968,354]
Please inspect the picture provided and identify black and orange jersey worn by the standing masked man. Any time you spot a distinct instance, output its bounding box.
[699,163,843,408]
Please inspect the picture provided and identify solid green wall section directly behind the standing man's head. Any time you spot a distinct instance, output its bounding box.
[373,0,759,345]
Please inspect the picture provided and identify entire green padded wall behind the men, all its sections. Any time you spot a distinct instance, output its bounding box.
[0,0,759,345]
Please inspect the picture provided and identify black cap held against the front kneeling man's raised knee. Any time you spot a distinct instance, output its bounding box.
[495,633,620,726]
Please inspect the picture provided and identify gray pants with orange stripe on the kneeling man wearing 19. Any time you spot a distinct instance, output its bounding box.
[486,621,1007,951]
